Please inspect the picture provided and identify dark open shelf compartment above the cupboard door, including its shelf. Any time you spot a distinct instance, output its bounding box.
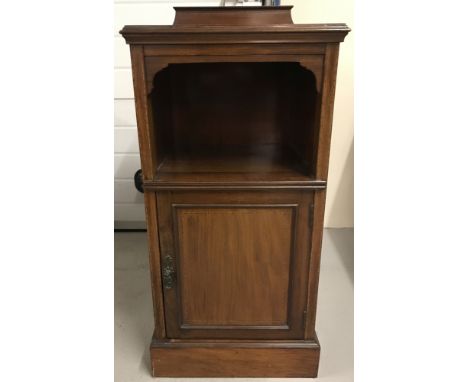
[145,62,324,188]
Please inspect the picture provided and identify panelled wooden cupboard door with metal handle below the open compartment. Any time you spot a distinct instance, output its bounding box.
[157,191,312,339]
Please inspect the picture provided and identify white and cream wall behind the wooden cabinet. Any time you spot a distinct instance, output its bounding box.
[114,0,354,228]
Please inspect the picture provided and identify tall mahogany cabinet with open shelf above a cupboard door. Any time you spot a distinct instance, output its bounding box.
[121,7,349,377]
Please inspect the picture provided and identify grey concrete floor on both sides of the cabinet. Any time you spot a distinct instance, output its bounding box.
[114,229,354,382]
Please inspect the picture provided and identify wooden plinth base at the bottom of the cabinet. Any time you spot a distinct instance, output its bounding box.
[150,340,320,378]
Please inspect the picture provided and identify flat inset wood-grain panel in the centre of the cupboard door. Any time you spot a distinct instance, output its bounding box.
[173,205,297,327]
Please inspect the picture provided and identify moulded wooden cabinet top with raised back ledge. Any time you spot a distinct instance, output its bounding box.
[120,6,350,43]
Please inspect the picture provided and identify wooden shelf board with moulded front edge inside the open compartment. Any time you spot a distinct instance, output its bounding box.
[144,145,326,190]
